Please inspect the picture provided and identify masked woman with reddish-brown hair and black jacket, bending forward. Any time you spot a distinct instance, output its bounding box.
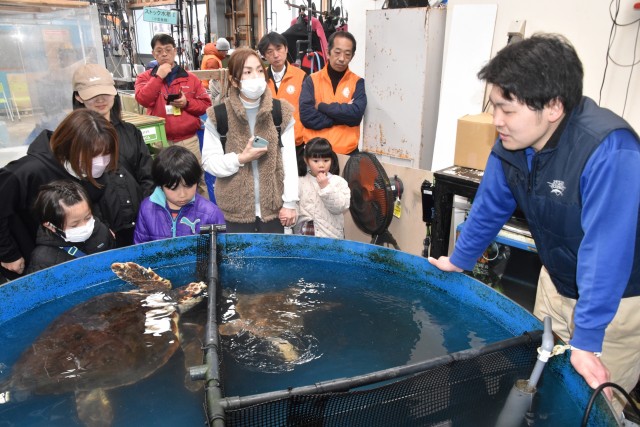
[0,109,118,282]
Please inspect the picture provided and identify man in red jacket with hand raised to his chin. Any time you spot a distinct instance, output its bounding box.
[136,34,211,199]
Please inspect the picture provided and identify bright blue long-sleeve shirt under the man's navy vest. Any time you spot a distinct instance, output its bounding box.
[451,130,640,351]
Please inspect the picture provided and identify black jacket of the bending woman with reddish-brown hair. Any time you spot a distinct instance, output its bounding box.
[0,131,106,277]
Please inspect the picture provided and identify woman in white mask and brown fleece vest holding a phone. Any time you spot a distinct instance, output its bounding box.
[202,48,298,233]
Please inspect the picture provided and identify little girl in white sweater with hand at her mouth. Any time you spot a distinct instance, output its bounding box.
[294,138,351,239]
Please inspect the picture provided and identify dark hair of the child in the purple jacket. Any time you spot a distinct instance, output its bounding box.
[151,145,202,190]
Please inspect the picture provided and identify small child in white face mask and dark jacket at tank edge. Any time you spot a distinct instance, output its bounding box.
[25,180,116,274]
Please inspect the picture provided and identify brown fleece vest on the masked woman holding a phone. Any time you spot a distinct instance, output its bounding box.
[207,87,293,223]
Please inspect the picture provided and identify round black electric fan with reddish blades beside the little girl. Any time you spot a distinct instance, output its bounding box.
[342,152,402,250]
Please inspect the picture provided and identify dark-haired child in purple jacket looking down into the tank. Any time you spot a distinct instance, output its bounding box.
[133,145,224,243]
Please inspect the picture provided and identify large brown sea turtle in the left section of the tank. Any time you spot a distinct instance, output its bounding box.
[0,262,207,426]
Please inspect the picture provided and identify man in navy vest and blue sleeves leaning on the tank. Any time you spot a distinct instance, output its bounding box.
[429,34,640,413]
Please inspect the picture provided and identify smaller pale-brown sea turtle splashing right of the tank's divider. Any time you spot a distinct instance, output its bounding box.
[218,287,335,364]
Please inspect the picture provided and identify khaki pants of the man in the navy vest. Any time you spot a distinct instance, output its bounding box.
[533,267,640,416]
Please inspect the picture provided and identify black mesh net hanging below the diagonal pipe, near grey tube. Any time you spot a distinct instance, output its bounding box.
[220,336,540,427]
